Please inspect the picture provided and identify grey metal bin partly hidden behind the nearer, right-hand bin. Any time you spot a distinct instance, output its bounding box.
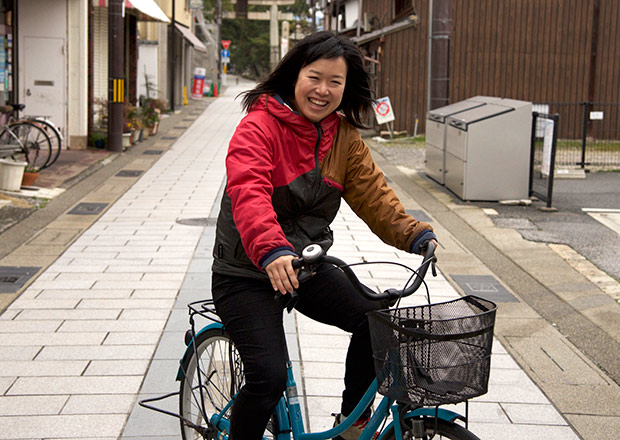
[424,96,501,185]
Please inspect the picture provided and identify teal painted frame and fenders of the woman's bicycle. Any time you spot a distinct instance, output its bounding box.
[182,323,466,440]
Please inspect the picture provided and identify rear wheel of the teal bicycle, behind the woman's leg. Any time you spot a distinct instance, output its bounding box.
[179,328,278,440]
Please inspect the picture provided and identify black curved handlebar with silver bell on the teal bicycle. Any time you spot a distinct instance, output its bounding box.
[293,241,437,301]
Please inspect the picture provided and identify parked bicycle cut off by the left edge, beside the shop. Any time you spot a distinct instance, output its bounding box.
[0,104,63,171]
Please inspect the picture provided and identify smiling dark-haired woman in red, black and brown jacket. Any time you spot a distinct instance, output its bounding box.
[212,32,436,440]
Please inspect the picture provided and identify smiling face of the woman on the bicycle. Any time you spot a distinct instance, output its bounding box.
[294,57,347,122]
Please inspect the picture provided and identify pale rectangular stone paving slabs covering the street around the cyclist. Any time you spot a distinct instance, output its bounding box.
[0,83,579,440]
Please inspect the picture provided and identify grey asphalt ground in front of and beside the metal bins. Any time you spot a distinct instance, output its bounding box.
[367,139,620,286]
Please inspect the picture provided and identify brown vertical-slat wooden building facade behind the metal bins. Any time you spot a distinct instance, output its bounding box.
[347,0,620,139]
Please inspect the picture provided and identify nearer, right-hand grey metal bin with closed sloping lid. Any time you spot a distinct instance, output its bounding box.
[445,99,532,201]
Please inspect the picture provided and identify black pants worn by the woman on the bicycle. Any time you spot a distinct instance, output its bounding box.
[212,264,380,440]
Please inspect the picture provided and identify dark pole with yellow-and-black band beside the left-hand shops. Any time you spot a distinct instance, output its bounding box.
[108,0,125,153]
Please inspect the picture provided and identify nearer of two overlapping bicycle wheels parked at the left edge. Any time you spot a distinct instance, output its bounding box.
[2,121,52,170]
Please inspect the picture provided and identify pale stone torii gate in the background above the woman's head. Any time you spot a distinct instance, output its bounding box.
[222,0,295,69]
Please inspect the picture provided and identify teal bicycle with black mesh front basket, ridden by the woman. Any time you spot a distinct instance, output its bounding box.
[140,243,496,440]
